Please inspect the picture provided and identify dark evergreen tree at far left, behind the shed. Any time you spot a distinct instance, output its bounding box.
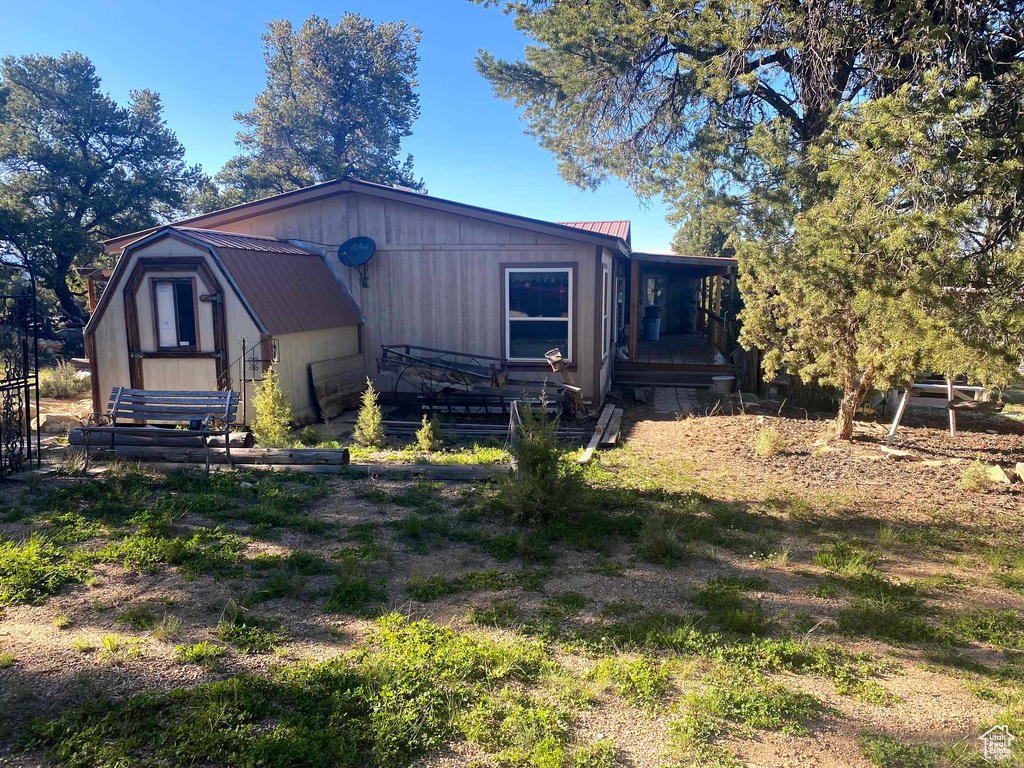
[0,53,197,319]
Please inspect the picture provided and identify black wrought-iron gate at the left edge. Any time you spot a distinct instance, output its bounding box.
[0,285,40,480]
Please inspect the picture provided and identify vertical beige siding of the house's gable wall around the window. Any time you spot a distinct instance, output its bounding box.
[211,194,610,397]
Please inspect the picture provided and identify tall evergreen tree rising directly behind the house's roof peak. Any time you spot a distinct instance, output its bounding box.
[201,13,423,210]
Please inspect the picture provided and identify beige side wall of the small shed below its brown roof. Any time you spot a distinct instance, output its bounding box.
[274,326,359,421]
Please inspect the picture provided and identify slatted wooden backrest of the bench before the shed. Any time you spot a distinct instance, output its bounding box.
[106,387,239,425]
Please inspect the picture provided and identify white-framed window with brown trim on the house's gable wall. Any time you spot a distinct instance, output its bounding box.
[505,267,572,360]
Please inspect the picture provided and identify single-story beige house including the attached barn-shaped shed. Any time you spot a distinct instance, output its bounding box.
[85,178,735,418]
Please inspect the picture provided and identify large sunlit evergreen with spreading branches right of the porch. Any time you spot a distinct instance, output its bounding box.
[477,0,1024,437]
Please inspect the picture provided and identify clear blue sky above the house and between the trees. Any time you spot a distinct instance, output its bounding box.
[6,0,673,251]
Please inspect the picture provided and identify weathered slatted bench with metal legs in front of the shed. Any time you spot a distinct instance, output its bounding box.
[81,387,239,472]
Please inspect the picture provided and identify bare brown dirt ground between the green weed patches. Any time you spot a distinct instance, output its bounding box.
[0,403,1024,767]
